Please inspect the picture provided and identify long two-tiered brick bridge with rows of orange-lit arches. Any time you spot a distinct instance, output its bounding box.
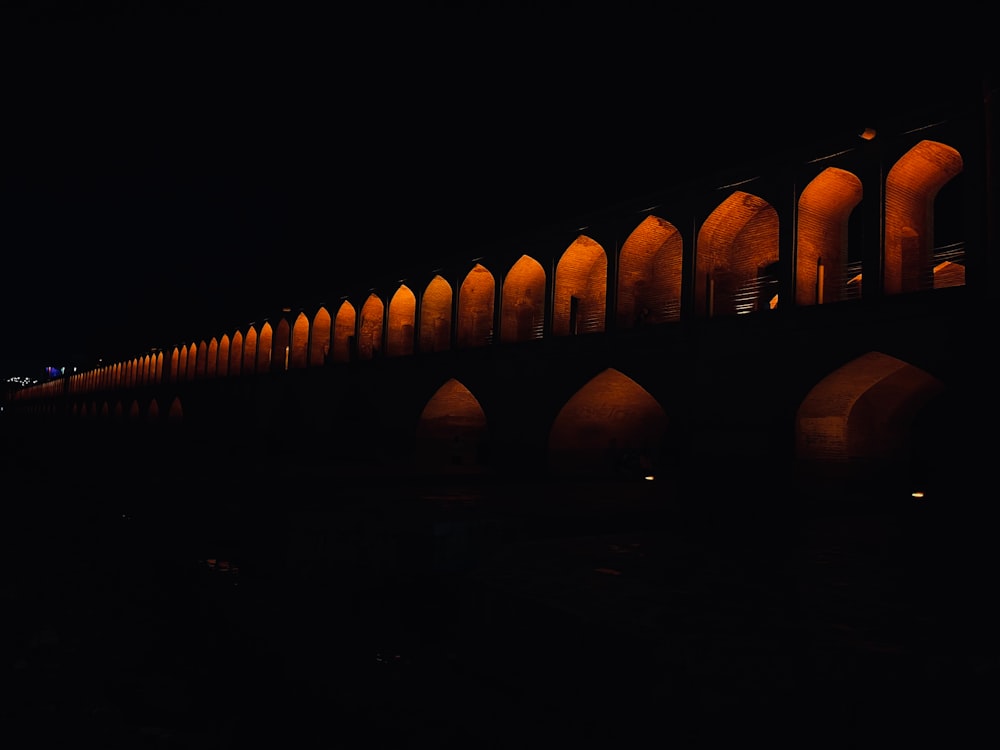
[5,85,996,502]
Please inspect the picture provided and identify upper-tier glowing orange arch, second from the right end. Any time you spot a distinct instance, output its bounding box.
[795,167,864,305]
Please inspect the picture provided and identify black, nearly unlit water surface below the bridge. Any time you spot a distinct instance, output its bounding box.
[0,444,1000,748]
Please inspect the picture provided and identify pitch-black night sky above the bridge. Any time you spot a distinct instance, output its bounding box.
[0,2,992,377]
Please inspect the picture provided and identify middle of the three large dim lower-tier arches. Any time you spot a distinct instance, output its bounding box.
[548,368,667,477]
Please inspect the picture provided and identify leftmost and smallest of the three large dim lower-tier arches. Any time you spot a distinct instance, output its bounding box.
[415,378,488,474]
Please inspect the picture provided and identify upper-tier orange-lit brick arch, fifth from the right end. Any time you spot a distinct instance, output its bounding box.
[552,234,608,336]
